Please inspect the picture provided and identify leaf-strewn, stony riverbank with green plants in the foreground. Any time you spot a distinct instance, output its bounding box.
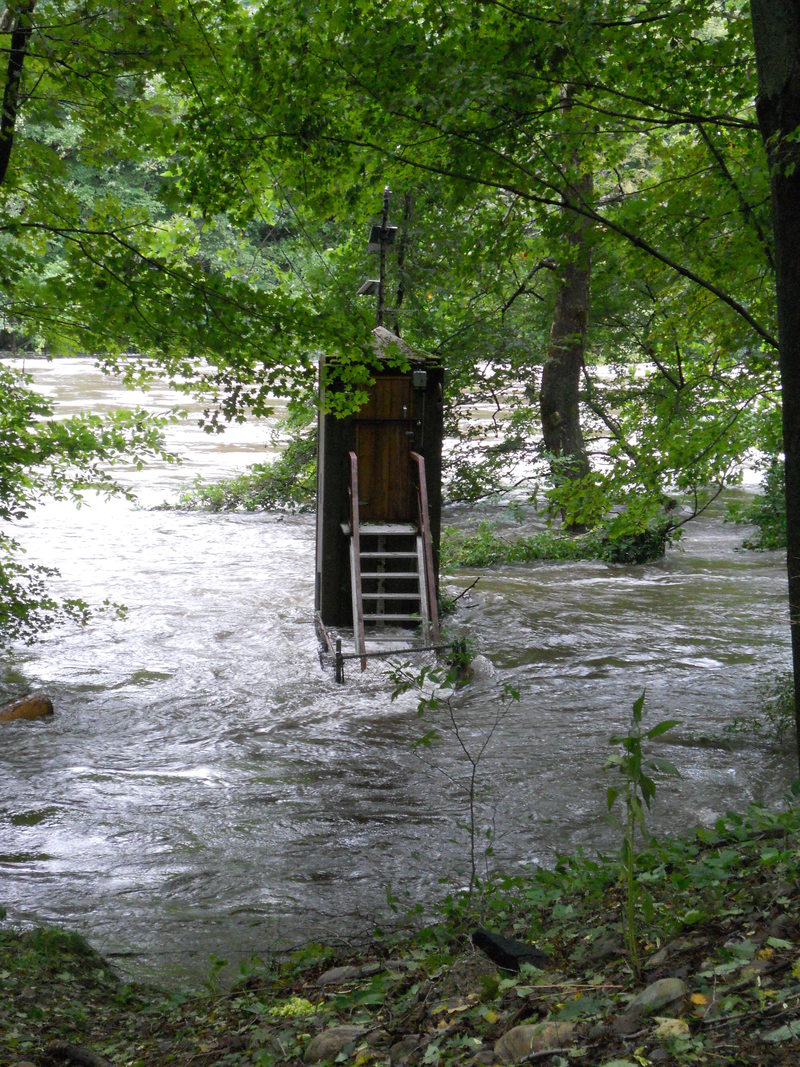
[0,807,800,1067]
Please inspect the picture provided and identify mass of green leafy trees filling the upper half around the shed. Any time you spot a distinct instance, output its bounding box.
[0,0,778,532]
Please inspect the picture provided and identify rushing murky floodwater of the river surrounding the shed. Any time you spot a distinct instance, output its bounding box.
[0,361,795,977]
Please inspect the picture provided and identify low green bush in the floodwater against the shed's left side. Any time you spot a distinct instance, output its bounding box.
[177,430,317,511]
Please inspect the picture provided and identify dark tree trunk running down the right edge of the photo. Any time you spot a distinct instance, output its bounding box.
[750,0,800,763]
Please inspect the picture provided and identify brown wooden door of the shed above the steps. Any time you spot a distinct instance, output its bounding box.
[355,377,416,523]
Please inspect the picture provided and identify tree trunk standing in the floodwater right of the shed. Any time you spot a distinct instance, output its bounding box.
[539,168,592,481]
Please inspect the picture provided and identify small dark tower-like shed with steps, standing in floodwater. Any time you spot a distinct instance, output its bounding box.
[315,327,443,667]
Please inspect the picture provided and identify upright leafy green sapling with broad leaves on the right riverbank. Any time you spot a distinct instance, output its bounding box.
[603,690,681,976]
